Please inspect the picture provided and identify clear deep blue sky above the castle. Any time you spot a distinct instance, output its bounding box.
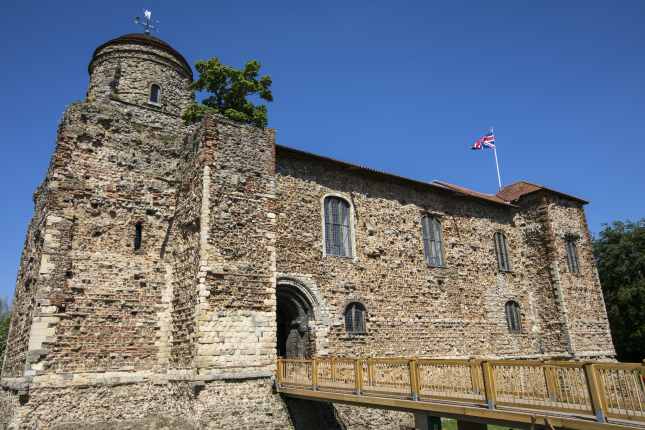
[0,0,645,302]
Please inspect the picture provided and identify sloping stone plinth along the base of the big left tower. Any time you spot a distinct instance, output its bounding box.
[0,379,292,430]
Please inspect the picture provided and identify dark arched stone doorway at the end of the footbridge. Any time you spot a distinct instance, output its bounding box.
[276,283,314,358]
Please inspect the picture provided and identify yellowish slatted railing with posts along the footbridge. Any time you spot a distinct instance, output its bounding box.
[276,357,645,422]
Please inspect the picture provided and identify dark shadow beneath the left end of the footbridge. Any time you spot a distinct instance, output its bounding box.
[284,398,347,430]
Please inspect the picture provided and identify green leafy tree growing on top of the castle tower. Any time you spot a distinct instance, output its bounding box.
[183,58,273,128]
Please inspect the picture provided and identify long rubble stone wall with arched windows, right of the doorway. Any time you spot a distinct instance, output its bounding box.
[276,149,612,357]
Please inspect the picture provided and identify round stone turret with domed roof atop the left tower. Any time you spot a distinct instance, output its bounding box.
[87,34,193,115]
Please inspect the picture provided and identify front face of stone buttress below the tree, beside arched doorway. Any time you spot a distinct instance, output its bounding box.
[196,118,276,375]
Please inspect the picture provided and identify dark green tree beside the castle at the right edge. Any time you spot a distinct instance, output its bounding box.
[594,219,645,362]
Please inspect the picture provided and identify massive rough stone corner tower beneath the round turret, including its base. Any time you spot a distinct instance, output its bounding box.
[0,101,291,429]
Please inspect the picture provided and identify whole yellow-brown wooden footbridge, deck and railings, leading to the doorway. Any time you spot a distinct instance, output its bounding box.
[276,358,645,430]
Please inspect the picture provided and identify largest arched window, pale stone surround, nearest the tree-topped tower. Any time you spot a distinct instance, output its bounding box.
[324,196,352,257]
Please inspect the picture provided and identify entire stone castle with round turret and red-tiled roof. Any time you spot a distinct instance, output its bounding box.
[0,34,615,429]
